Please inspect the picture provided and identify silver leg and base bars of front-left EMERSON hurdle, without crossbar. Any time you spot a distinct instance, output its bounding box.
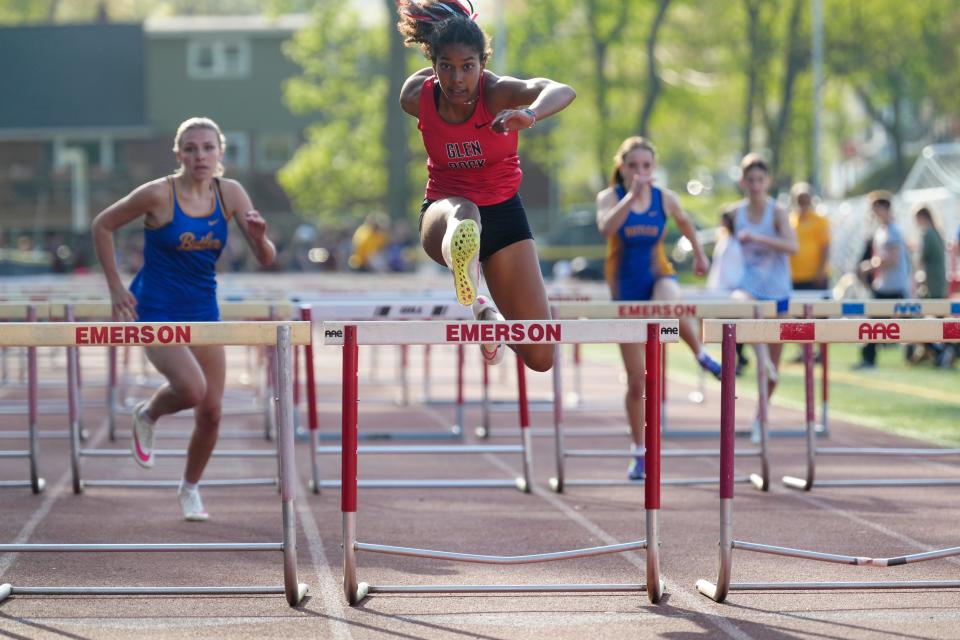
[0,325,308,606]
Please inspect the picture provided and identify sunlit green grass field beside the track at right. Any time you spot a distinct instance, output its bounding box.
[584,345,960,447]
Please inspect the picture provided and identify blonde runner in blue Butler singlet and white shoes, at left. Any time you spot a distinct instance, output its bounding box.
[93,118,277,520]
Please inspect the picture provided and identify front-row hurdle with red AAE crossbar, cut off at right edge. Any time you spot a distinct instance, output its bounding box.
[697,319,960,602]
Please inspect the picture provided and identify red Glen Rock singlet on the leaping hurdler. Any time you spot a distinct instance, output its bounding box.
[417,75,523,207]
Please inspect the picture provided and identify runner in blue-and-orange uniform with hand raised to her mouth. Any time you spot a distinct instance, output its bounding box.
[597,137,720,480]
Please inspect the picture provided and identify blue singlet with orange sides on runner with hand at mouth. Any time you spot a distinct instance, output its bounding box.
[604,185,674,300]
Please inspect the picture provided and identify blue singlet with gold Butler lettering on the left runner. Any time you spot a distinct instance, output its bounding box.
[130,179,227,322]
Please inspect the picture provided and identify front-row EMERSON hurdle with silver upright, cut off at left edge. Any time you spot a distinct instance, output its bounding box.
[0,322,310,606]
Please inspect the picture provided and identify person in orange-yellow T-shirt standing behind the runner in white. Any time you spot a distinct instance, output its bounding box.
[790,182,830,291]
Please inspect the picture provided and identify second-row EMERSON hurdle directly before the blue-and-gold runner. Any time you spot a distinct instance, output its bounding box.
[549,300,776,493]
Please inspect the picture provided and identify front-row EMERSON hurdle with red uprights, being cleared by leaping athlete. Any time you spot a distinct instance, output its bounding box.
[323,320,679,605]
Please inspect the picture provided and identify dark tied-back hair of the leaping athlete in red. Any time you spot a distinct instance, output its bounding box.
[397,0,491,62]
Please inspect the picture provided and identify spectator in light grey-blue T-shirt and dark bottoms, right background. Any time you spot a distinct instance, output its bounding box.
[854,191,911,369]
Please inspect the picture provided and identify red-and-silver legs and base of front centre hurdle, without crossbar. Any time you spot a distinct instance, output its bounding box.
[341,324,663,605]
